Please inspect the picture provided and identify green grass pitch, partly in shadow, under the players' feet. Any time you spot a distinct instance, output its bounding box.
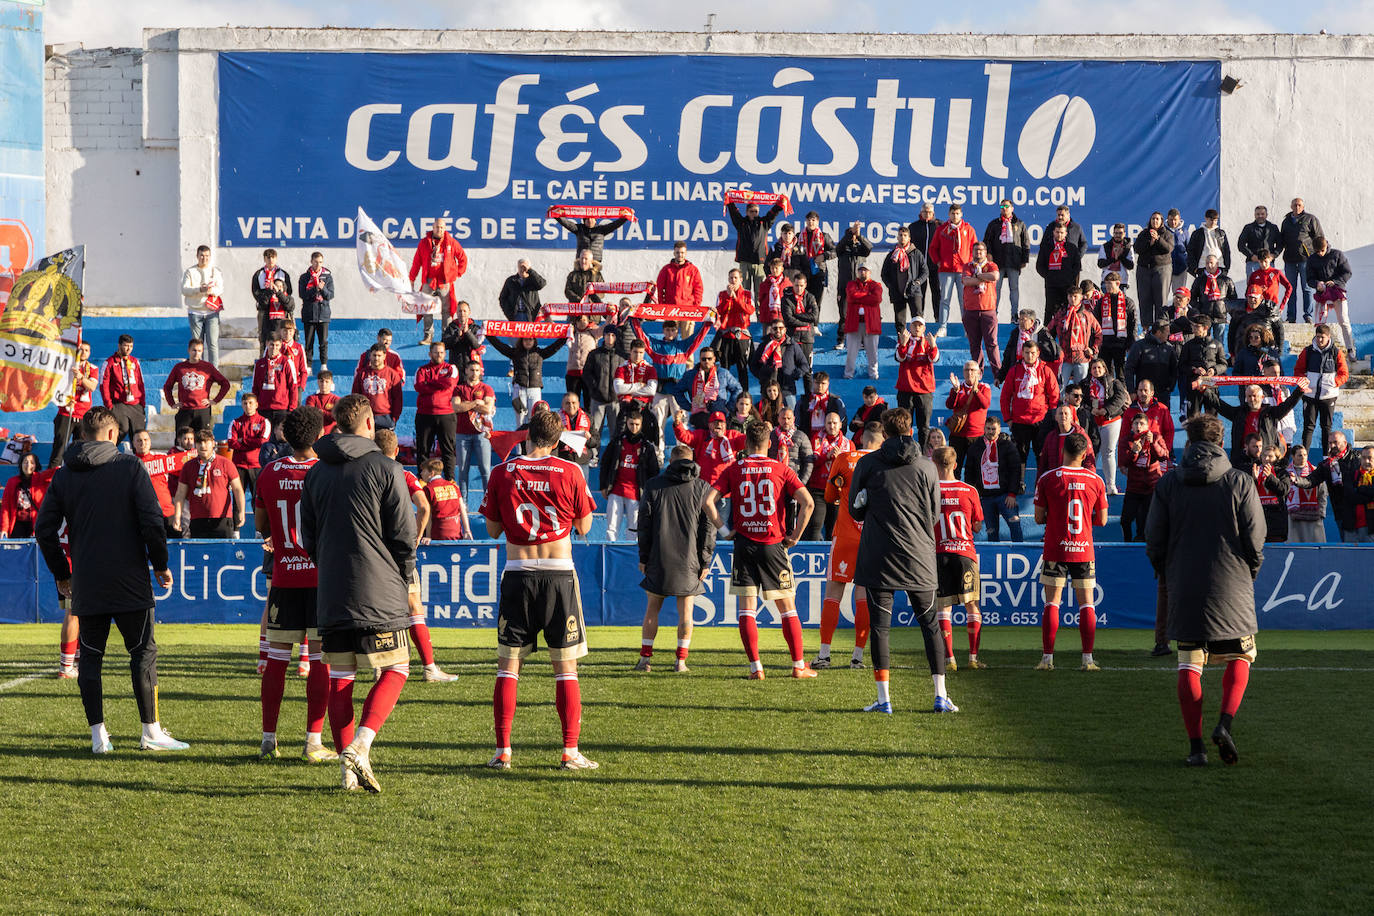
[0,618,1374,915]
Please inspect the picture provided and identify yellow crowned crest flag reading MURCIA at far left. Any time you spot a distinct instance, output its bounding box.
[0,244,85,411]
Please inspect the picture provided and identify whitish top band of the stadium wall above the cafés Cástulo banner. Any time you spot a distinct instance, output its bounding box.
[131,26,1374,60]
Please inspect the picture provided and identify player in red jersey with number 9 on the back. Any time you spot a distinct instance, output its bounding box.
[1035,433,1107,672]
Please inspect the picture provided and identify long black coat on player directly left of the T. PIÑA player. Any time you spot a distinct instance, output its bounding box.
[301,431,415,633]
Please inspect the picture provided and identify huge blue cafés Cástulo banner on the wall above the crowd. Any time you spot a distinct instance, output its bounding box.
[218,52,1221,249]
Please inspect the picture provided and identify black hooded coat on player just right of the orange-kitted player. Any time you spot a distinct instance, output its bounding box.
[849,437,940,596]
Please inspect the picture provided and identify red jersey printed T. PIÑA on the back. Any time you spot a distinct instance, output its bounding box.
[480,455,595,547]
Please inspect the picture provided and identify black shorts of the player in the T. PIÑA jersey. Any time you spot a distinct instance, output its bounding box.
[496,560,587,662]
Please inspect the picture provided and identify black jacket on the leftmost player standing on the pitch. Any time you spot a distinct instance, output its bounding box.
[33,442,168,615]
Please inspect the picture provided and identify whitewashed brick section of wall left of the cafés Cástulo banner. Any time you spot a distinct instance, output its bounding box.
[44,48,143,151]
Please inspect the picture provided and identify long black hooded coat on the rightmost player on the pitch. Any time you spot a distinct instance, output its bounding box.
[1145,442,1267,641]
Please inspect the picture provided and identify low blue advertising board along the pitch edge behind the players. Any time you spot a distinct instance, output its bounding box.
[16,541,1374,630]
